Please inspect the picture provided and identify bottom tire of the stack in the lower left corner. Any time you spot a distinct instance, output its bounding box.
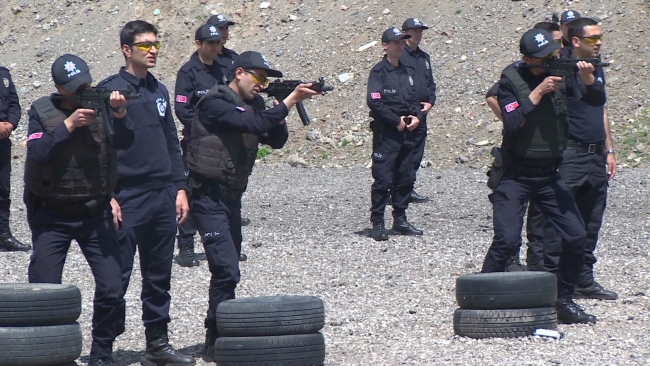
[0,323,82,366]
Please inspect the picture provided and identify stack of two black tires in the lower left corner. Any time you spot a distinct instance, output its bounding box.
[0,283,82,366]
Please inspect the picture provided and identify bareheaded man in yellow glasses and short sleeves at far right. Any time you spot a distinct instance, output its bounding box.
[524,18,618,300]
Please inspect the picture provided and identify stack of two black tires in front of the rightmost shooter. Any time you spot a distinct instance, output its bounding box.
[454,272,557,339]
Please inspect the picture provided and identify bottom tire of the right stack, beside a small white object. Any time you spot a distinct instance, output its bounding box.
[454,307,557,339]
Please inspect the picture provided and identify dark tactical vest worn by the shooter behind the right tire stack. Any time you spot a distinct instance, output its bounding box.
[502,67,567,159]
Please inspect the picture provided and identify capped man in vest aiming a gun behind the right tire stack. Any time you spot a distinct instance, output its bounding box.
[482,29,606,323]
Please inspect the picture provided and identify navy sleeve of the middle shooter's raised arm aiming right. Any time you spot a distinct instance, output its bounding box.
[199,95,289,135]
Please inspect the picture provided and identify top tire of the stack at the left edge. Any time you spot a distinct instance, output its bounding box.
[0,283,81,327]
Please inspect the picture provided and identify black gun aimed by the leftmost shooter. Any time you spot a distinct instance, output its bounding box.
[52,87,140,136]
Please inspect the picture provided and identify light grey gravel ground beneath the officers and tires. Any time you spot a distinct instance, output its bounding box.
[0,164,650,365]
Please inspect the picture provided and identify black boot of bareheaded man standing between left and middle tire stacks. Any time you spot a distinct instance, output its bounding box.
[142,324,196,366]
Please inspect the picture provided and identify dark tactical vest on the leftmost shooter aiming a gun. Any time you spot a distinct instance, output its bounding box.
[25,97,117,203]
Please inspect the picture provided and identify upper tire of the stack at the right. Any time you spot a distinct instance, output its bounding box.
[456,272,557,310]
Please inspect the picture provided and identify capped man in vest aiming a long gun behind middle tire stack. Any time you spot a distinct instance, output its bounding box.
[187,51,317,360]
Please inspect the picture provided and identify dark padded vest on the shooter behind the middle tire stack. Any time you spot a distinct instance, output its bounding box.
[187,85,259,189]
